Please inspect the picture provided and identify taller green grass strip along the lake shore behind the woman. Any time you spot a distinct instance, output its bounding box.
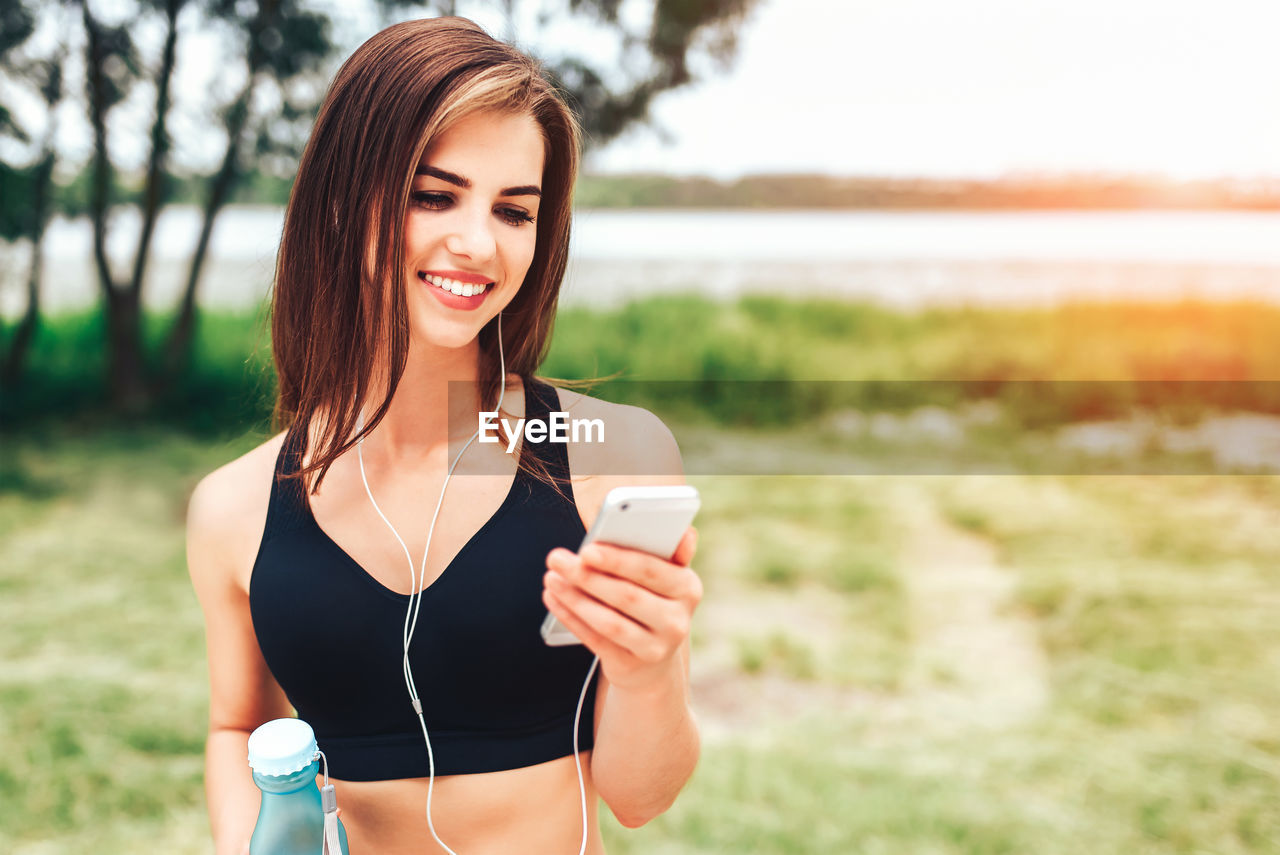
[10,294,1280,435]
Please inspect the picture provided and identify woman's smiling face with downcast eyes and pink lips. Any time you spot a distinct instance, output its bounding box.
[404,111,544,348]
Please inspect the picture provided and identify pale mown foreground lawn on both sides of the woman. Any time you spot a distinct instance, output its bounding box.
[0,429,1280,855]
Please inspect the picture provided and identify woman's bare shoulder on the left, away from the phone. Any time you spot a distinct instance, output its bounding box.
[187,431,284,591]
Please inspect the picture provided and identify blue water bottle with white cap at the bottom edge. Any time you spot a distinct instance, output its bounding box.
[248,718,349,855]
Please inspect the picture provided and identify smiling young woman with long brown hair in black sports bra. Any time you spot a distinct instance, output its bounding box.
[188,18,701,855]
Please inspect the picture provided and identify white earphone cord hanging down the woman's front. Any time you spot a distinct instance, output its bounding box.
[356,312,600,855]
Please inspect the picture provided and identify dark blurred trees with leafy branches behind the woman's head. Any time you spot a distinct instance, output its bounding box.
[0,0,758,412]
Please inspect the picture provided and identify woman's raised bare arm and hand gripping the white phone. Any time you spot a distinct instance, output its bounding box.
[544,407,701,828]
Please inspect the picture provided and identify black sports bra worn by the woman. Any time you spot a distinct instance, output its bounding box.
[248,379,599,781]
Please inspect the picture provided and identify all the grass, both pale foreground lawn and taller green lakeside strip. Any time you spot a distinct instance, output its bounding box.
[0,291,1280,855]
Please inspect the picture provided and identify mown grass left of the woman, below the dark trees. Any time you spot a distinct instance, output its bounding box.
[0,431,262,851]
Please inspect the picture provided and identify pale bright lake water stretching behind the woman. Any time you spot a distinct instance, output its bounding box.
[0,206,1280,316]
